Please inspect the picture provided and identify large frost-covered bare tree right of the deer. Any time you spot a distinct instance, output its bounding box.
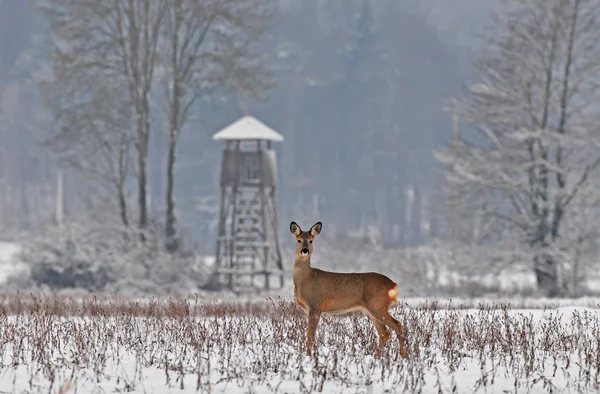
[437,0,600,296]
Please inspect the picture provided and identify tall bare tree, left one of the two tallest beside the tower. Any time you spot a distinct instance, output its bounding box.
[40,0,166,228]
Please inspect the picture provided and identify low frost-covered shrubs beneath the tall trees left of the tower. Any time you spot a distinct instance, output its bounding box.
[14,222,207,294]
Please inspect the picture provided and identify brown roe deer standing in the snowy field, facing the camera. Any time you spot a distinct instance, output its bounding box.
[290,222,407,358]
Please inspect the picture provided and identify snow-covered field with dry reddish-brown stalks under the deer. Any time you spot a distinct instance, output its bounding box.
[0,294,600,393]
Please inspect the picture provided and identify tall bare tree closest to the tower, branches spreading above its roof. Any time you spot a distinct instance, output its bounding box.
[162,0,273,250]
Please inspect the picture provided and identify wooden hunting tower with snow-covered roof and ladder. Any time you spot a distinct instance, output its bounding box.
[213,116,283,291]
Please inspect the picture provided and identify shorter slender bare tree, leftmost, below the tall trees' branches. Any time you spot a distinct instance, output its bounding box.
[42,77,134,226]
